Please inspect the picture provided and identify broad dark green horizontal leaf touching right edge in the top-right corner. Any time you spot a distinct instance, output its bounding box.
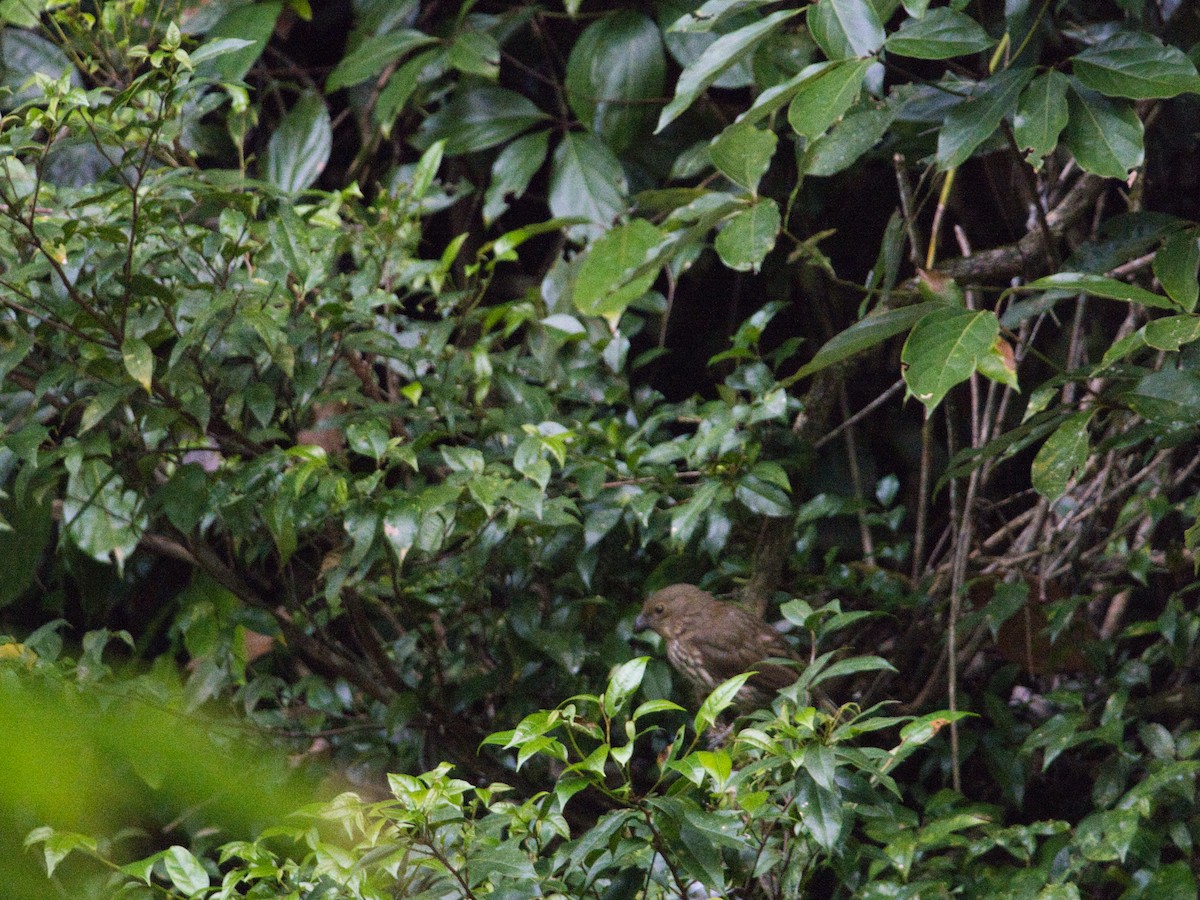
[1072,31,1200,100]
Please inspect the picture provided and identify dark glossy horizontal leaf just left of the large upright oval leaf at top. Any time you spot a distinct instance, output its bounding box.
[413,83,547,156]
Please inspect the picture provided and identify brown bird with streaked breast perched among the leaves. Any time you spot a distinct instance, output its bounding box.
[635,584,798,709]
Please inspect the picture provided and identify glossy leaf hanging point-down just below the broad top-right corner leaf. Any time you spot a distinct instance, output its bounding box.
[1062,84,1145,180]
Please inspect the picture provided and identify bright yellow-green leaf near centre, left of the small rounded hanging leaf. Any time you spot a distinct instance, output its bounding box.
[572,218,662,322]
